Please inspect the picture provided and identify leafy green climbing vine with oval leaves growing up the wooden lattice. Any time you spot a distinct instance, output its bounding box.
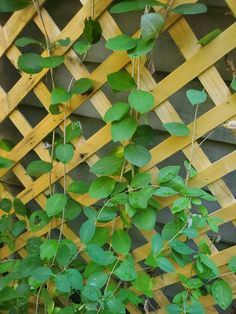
[0,0,236,314]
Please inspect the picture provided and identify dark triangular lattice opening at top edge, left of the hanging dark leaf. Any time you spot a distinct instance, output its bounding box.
[44,0,82,30]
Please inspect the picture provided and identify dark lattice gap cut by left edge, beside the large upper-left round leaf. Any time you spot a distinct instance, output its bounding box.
[0,55,20,92]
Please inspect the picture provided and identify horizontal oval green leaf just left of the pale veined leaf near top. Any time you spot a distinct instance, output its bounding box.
[106,34,136,51]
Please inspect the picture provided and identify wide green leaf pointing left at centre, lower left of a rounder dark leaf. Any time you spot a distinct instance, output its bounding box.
[90,156,123,176]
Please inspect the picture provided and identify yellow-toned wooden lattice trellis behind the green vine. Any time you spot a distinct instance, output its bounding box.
[0,0,236,313]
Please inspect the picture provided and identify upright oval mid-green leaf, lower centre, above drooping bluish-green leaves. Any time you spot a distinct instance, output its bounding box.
[111,229,131,255]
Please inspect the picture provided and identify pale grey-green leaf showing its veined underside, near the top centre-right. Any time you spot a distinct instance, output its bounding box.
[141,13,165,41]
